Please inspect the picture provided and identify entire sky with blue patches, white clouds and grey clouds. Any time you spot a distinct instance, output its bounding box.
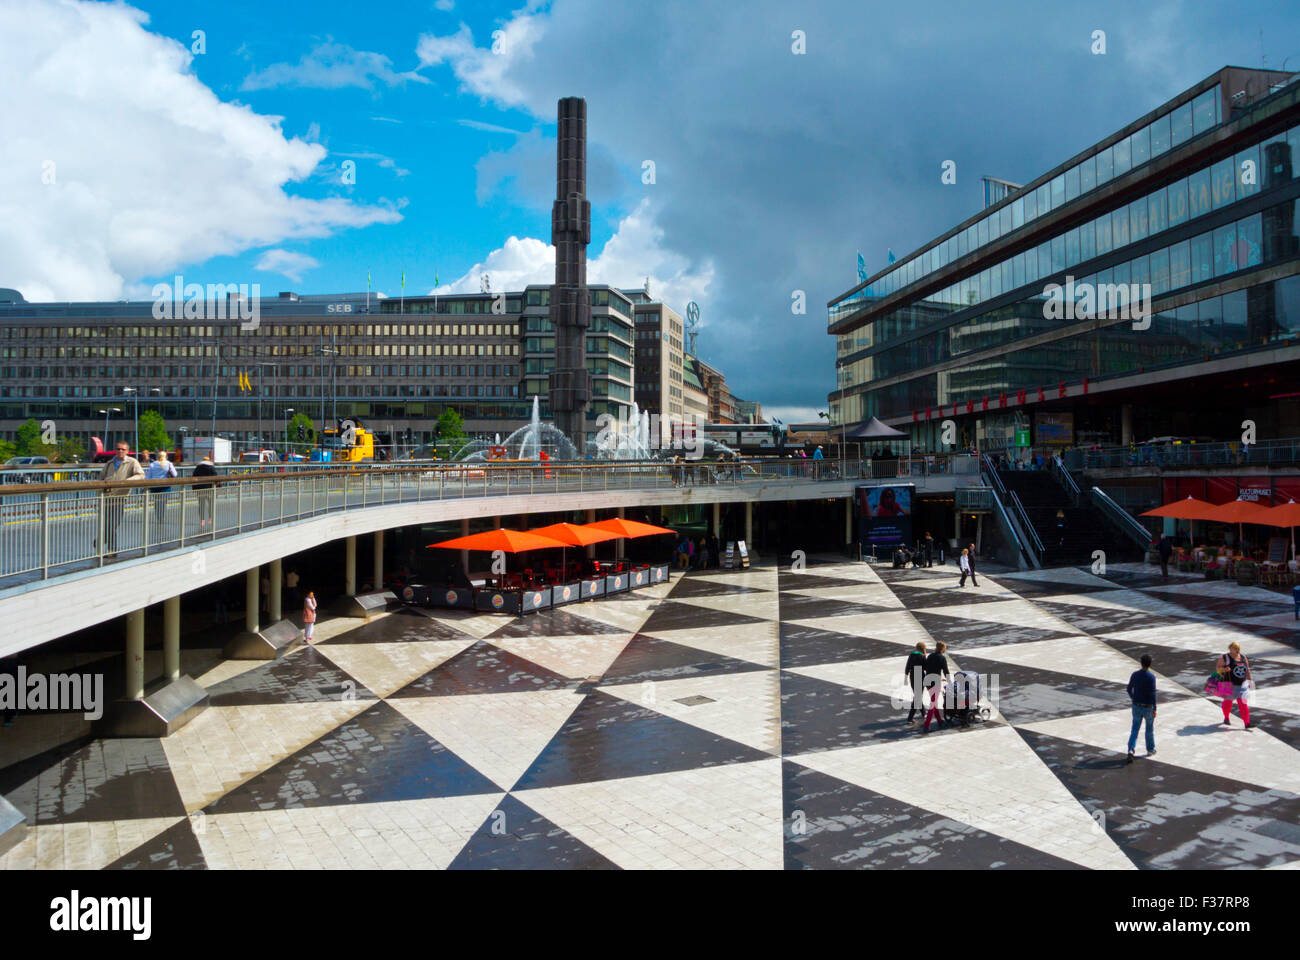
[0,0,1300,420]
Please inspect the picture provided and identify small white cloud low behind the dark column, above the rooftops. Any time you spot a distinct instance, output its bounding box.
[430,199,715,313]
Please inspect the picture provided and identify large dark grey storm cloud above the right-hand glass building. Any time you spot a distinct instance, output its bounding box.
[439,0,1300,406]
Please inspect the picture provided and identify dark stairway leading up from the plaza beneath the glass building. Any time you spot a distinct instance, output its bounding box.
[998,470,1141,567]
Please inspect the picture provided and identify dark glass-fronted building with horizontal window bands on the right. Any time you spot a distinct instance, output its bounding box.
[828,66,1300,450]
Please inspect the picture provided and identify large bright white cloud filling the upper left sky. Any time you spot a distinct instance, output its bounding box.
[0,0,402,300]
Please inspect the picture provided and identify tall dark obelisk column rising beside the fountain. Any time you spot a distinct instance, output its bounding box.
[550,96,592,457]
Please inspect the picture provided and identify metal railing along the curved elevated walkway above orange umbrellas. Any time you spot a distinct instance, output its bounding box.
[0,459,904,588]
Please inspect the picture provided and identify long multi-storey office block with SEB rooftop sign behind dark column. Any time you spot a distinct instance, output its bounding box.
[0,286,633,442]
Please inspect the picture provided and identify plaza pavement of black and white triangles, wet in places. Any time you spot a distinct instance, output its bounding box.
[0,562,1300,869]
